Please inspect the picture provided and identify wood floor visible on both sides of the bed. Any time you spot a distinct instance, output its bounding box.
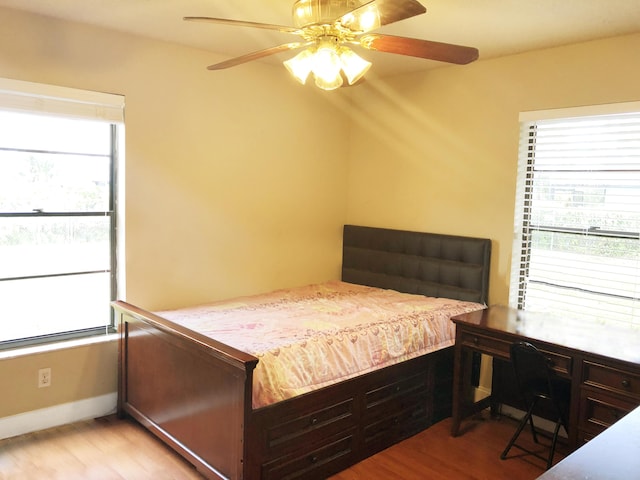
[0,413,561,480]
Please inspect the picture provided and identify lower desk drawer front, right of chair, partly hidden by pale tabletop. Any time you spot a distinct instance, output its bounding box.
[579,388,638,435]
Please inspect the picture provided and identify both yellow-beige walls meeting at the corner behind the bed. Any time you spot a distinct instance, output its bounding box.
[0,3,640,426]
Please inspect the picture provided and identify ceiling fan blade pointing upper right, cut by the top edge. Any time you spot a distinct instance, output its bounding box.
[338,0,427,33]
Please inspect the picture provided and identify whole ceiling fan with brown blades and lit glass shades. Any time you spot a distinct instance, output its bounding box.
[184,0,478,90]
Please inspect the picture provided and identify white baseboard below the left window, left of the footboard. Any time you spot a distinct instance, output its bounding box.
[0,392,118,440]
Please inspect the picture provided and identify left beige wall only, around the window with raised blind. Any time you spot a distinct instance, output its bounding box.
[0,8,349,418]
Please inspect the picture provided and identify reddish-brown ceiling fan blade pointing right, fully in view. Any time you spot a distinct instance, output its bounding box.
[358,33,478,65]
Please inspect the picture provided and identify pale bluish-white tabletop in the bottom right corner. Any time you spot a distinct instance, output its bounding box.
[538,408,640,480]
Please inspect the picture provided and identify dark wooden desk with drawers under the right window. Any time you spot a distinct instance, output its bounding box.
[451,306,640,449]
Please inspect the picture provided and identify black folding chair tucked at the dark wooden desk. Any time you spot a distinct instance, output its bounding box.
[500,342,571,469]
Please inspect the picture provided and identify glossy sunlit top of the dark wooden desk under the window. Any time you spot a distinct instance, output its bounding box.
[452,306,640,364]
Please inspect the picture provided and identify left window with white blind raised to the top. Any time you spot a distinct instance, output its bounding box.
[0,79,122,348]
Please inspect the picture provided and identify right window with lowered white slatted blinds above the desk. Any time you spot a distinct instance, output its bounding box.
[510,103,640,328]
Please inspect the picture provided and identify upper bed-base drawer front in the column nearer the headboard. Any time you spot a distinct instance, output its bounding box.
[364,372,428,420]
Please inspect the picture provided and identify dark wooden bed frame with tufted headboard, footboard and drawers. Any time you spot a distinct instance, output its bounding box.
[113,225,491,480]
